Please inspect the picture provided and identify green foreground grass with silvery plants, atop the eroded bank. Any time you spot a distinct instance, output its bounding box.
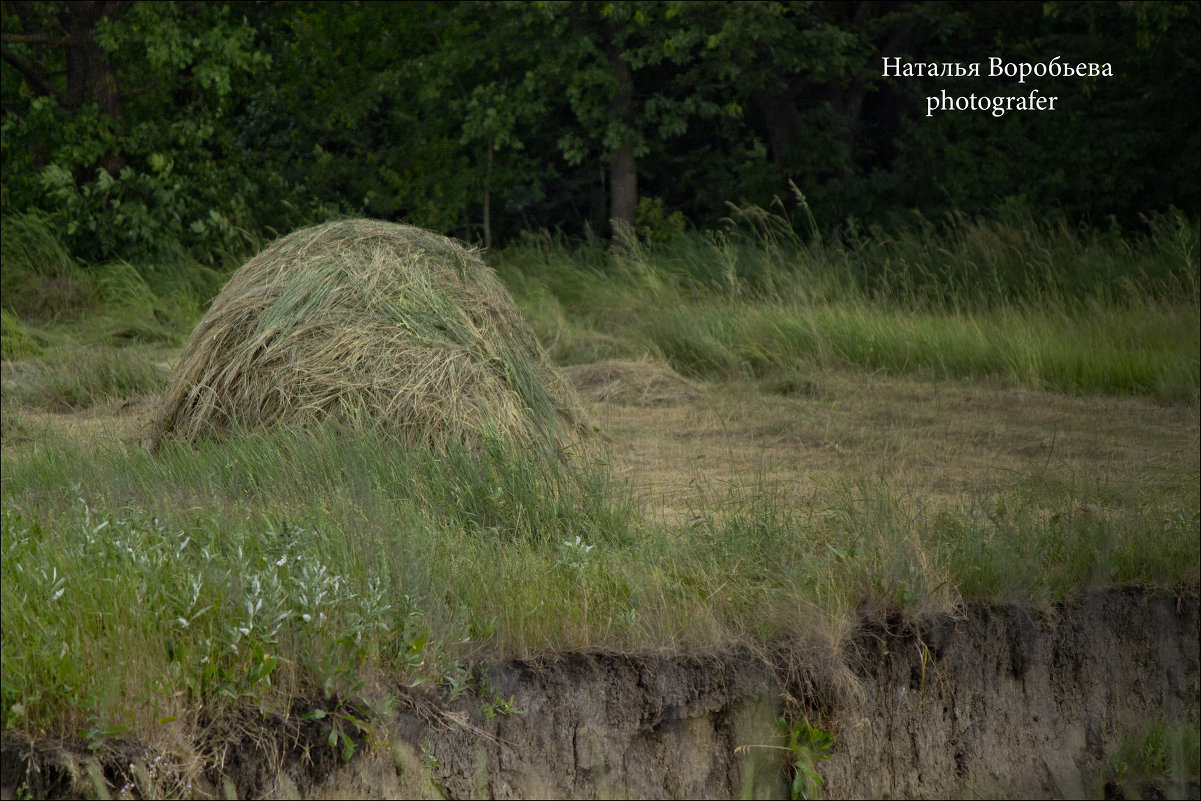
[0,429,1201,735]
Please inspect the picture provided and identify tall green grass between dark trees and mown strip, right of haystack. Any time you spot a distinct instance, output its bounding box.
[496,209,1201,401]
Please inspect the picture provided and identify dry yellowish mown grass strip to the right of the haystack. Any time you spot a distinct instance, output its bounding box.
[581,371,1201,518]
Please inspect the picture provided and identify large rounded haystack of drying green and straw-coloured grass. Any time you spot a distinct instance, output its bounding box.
[150,220,587,448]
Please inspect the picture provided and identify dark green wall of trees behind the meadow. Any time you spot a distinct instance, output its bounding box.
[0,0,1201,259]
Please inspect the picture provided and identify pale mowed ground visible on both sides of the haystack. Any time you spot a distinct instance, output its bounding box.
[5,349,1201,521]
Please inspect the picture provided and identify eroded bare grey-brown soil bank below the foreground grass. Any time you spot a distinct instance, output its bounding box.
[4,588,1201,797]
